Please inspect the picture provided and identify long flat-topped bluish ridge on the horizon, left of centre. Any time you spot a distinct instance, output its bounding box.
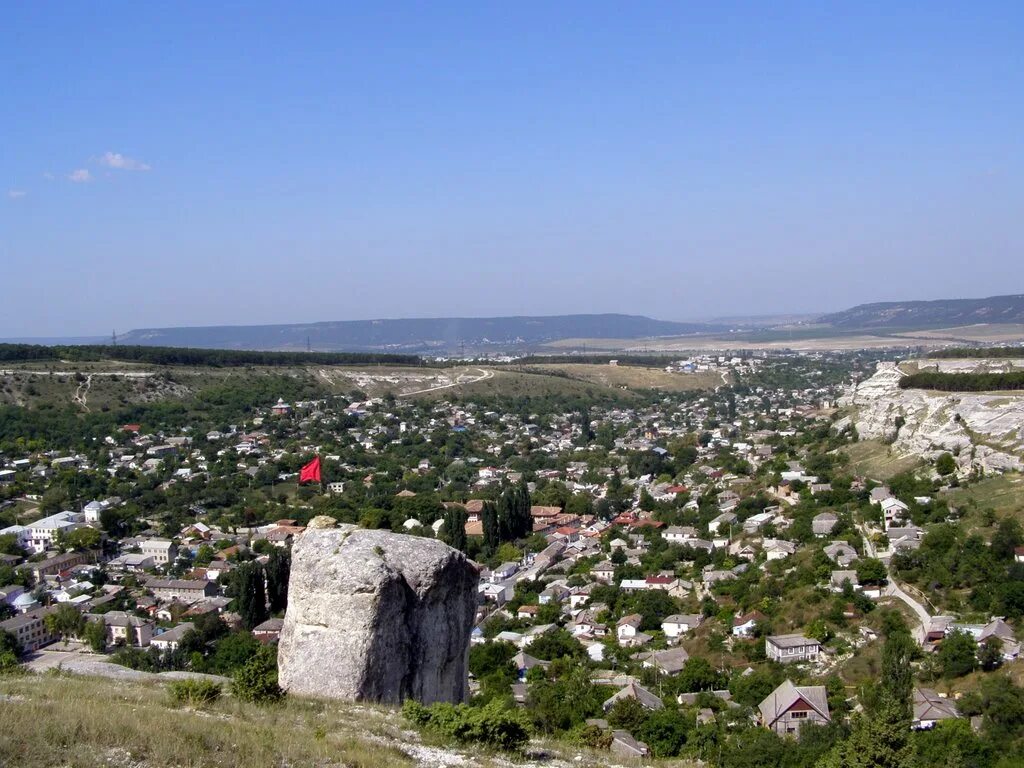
[119,314,727,352]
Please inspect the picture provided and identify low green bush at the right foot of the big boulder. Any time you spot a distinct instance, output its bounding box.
[401,699,529,752]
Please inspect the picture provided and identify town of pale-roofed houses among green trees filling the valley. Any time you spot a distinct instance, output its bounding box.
[0,351,1024,765]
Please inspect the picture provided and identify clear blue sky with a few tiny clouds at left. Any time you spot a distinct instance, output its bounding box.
[0,0,1024,338]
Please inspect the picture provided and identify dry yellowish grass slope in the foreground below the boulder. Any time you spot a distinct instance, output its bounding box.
[0,675,414,768]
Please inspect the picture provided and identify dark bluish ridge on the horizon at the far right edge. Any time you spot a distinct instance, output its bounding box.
[817,294,1024,331]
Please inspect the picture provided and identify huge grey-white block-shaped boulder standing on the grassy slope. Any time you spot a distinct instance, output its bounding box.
[278,525,479,703]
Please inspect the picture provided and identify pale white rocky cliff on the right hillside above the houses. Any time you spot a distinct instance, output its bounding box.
[840,359,1024,474]
